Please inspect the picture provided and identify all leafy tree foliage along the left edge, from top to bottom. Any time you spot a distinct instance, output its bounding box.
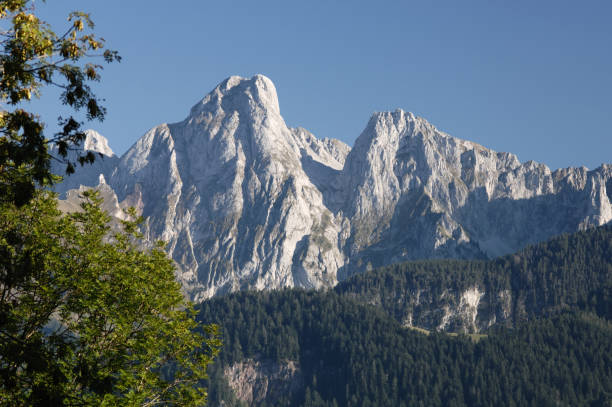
[0,0,220,406]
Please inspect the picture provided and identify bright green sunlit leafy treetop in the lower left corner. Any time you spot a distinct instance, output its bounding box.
[0,192,220,406]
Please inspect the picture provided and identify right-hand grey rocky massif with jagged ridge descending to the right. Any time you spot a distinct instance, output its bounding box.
[342,110,612,278]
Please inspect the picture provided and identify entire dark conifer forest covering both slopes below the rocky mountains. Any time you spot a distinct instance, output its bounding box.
[199,227,612,406]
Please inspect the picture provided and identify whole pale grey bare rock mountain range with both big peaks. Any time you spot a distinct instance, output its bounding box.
[58,75,612,306]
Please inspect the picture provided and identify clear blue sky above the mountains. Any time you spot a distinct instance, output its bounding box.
[33,0,612,169]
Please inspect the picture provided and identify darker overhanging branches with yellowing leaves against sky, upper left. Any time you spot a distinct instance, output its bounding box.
[0,0,120,205]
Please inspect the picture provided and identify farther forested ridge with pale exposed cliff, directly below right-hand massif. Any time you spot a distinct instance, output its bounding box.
[335,226,612,332]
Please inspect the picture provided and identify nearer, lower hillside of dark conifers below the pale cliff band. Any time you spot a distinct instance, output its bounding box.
[201,290,612,406]
